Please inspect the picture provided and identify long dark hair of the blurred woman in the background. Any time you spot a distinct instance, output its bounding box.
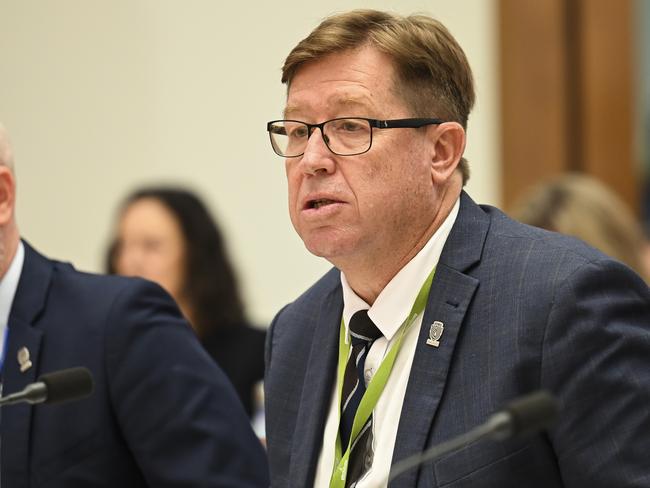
[106,187,244,337]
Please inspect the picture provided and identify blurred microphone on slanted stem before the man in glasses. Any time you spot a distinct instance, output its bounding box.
[387,390,558,482]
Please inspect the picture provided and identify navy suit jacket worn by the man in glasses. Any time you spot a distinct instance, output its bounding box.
[265,193,650,488]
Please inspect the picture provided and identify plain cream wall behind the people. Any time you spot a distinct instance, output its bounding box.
[0,0,500,325]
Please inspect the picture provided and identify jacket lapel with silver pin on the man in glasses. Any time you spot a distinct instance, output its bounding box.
[390,192,489,488]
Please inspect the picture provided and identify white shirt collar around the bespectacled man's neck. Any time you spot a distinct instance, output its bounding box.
[341,198,460,341]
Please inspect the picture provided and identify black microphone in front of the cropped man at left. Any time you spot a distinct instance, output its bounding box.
[0,367,93,407]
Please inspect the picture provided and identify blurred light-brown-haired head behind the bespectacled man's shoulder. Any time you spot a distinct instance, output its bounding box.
[511,174,650,282]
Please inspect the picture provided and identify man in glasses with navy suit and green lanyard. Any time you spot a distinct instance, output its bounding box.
[265,10,650,488]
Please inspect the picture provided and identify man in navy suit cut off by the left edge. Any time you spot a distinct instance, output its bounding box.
[0,123,269,488]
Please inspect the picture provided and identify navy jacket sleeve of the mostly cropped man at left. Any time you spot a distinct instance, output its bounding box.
[104,280,269,487]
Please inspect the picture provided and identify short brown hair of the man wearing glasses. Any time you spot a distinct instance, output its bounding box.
[282,10,475,184]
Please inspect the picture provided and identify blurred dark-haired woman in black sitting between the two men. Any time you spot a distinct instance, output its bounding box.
[106,187,265,416]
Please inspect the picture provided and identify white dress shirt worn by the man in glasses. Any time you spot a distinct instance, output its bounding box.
[314,199,460,488]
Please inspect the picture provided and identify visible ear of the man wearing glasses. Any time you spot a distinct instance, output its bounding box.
[429,122,466,183]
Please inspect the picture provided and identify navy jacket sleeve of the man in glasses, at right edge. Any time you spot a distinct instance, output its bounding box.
[541,259,650,488]
